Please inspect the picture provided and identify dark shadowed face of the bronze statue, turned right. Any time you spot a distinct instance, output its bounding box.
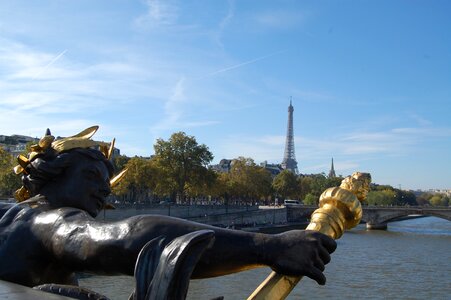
[42,155,111,217]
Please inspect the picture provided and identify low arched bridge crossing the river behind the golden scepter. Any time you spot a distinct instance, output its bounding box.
[287,205,451,229]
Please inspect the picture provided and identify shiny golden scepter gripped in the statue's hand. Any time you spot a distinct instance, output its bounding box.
[247,172,371,300]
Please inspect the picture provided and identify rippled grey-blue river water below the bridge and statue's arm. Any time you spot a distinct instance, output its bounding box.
[80,217,451,300]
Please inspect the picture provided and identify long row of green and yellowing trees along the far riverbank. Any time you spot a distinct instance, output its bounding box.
[0,132,450,206]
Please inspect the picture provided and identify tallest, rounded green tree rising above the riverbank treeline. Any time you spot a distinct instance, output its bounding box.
[154,132,213,201]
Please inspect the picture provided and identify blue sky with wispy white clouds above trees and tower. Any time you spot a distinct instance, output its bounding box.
[0,0,451,189]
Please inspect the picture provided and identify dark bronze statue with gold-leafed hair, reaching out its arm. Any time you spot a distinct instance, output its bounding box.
[0,127,336,298]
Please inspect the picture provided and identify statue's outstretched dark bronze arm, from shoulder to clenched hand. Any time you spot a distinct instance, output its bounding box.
[36,210,335,282]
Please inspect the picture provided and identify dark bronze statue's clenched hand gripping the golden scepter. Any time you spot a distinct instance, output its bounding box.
[271,230,337,285]
